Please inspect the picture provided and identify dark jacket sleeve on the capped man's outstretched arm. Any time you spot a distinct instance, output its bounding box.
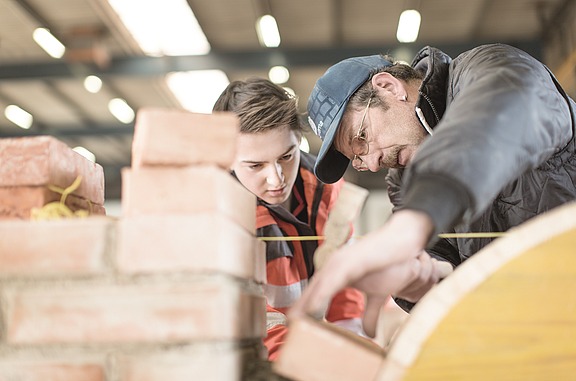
[403,44,572,240]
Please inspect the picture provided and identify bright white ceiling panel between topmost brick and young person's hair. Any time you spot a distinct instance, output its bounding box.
[166,70,230,114]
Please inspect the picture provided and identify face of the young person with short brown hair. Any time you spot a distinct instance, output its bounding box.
[232,126,300,205]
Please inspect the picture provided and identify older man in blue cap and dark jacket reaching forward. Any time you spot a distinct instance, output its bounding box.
[292,44,576,330]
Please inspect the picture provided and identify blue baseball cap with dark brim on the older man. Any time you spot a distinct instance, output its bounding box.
[308,55,392,184]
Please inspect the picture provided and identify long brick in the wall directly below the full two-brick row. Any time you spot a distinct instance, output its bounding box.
[4,276,266,345]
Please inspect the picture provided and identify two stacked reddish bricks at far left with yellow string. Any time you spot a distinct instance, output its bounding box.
[0,136,105,219]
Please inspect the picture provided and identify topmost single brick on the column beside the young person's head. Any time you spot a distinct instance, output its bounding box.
[132,108,240,168]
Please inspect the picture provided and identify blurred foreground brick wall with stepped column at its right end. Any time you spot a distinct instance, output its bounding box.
[0,110,265,381]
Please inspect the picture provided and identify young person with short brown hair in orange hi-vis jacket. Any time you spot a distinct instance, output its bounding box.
[213,78,364,360]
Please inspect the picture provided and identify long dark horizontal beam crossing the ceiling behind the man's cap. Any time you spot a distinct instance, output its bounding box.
[0,40,542,83]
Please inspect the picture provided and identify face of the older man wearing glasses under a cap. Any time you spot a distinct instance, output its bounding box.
[334,92,428,172]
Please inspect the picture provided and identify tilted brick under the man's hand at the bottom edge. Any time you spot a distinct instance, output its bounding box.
[273,318,385,381]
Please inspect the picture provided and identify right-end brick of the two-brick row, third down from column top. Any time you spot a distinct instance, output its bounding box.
[117,212,258,279]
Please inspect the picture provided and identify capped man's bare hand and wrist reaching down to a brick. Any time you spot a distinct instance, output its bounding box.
[289,210,433,317]
